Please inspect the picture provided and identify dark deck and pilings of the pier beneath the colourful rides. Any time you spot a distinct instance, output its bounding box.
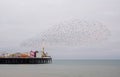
[0,58,52,64]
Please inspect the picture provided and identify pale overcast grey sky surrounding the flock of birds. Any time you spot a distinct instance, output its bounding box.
[0,0,120,59]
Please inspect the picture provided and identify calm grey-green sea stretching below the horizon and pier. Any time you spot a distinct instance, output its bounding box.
[0,60,120,77]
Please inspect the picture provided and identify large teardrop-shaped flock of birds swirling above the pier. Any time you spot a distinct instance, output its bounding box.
[21,19,110,47]
